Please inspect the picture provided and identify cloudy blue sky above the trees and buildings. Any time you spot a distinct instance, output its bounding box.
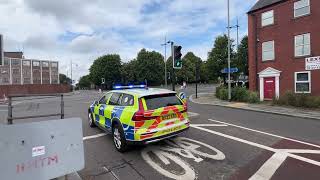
[0,0,257,80]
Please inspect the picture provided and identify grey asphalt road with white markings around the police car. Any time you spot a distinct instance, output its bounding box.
[0,86,320,180]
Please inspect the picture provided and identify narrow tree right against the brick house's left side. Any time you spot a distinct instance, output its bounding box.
[235,36,249,75]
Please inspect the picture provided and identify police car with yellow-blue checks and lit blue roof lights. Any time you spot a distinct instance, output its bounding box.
[88,85,189,152]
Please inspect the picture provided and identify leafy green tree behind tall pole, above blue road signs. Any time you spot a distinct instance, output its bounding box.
[206,34,235,81]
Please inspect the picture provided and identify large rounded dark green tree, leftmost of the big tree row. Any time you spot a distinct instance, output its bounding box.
[89,54,121,87]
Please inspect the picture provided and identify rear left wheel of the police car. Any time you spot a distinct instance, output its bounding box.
[112,124,127,152]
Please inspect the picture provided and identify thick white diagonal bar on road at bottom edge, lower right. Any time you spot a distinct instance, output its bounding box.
[249,153,287,180]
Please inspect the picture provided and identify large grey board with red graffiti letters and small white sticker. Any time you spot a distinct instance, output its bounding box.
[0,118,84,180]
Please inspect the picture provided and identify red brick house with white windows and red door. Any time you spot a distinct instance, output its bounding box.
[248,0,320,100]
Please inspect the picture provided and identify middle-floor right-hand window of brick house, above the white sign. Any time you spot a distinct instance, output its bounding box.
[294,33,311,57]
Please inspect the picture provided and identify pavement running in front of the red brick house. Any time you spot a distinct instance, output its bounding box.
[189,93,320,120]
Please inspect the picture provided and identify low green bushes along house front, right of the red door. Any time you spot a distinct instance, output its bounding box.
[273,91,320,108]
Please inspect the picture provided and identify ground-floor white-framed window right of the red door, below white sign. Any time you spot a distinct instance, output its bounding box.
[295,71,311,93]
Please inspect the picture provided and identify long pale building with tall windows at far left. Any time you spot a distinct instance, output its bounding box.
[0,57,59,85]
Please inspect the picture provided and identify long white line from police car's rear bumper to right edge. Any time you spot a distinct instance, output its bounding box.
[190,124,320,166]
